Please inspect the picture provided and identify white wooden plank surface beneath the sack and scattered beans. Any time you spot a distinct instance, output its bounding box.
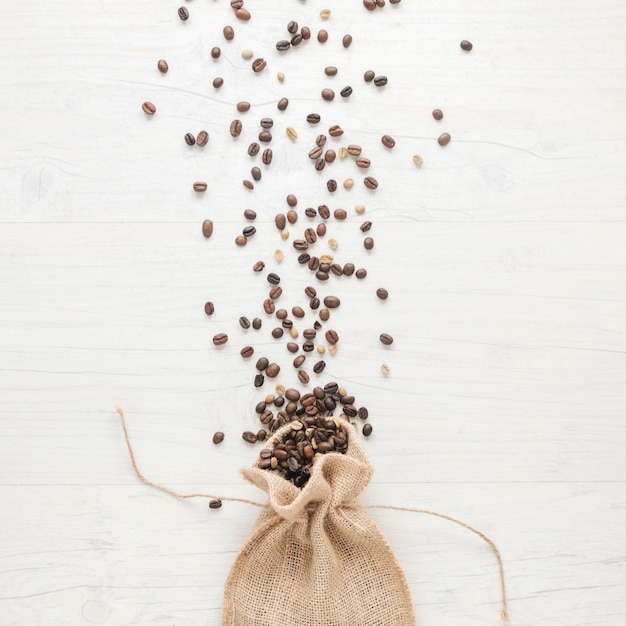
[0,0,626,626]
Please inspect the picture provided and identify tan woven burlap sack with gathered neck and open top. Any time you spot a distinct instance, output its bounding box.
[222,425,415,626]
